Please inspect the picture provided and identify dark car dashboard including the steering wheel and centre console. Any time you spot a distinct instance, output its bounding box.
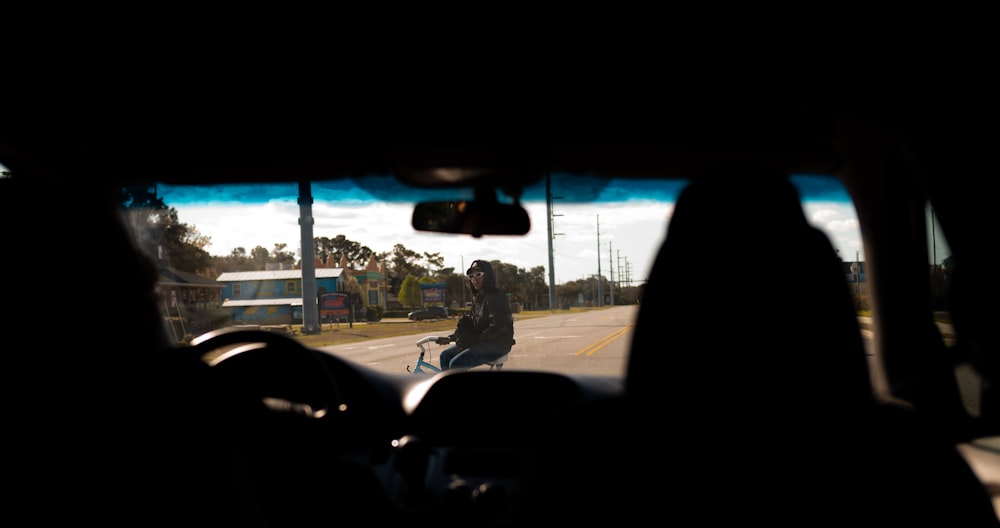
[187,330,623,525]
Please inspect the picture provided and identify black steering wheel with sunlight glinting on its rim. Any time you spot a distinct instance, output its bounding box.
[189,328,344,419]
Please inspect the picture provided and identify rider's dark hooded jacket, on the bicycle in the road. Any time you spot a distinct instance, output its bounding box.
[451,260,514,349]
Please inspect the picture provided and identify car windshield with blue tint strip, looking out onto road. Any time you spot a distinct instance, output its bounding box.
[124,170,865,377]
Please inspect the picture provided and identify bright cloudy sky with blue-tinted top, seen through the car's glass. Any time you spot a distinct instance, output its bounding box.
[152,174,888,285]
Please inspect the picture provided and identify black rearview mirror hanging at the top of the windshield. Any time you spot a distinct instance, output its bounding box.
[412,200,531,237]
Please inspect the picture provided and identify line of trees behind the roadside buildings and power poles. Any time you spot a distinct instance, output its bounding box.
[121,187,637,310]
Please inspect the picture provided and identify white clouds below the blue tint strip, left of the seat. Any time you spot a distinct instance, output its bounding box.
[172,201,671,283]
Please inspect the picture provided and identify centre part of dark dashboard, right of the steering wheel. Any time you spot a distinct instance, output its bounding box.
[388,371,621,522]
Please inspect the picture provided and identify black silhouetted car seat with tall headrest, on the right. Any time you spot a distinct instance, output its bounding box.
[623,166,996,526]
